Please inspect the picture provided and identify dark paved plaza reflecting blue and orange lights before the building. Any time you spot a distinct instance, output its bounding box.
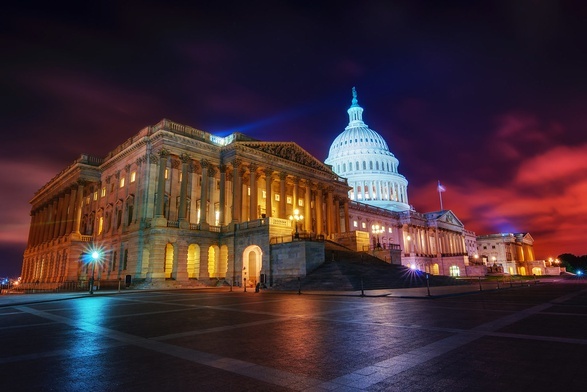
[0,280,587,392]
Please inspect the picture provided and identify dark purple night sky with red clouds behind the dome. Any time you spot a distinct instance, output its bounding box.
[0,0,587,276]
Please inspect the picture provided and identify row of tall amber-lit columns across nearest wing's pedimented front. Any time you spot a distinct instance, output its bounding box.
[155,151,349,234]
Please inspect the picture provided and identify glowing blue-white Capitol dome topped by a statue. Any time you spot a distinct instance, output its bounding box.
[325,87,410,211]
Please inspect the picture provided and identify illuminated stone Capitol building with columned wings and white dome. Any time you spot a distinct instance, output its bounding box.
[22,88,548,285]
